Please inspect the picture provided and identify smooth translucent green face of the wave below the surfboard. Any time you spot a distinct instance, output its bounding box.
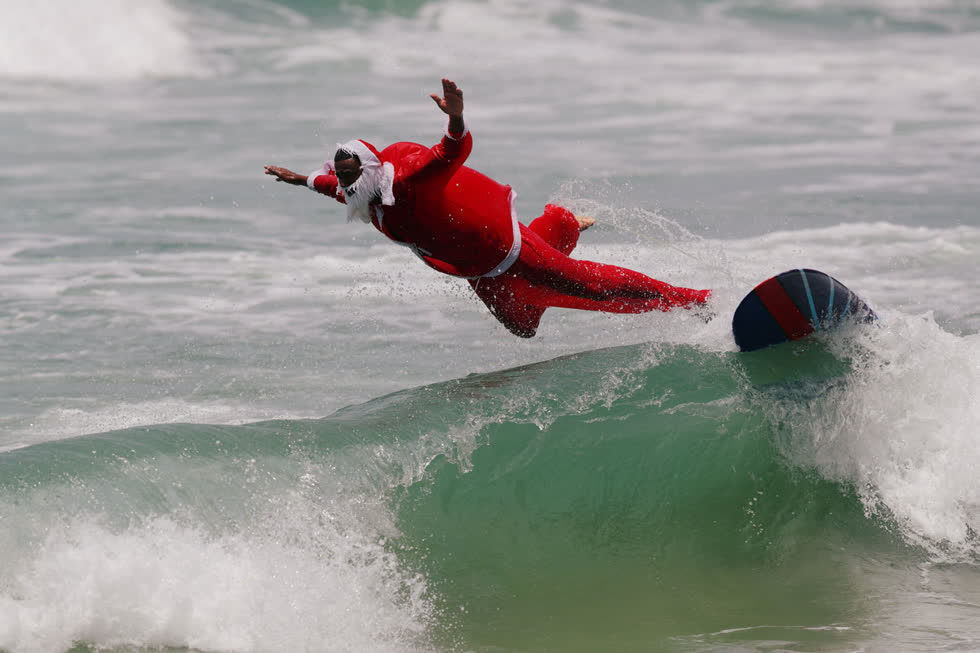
[384,346,904,650]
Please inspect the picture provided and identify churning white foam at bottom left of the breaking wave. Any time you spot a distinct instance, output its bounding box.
[0,509,430,653]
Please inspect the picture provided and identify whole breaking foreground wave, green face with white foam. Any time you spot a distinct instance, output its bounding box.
[0,336,980,651]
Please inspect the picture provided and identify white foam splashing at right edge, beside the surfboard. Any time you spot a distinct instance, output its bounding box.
[783,311,980,561]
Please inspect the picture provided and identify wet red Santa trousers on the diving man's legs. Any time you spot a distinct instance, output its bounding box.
[470,204,711,338]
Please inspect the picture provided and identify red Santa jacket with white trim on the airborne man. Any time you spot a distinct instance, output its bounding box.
[310,130,520,278]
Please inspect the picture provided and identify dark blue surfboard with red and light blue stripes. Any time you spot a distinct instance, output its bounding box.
[732,269,878,351]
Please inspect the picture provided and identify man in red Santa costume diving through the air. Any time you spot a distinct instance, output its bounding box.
[265,79,711,338]
